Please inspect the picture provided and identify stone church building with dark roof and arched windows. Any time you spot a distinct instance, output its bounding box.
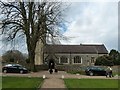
[35,43,108,65]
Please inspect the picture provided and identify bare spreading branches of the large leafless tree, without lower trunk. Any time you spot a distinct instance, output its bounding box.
[1,0,67,45]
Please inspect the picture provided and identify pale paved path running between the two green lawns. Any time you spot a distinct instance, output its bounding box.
[40,72,66,90]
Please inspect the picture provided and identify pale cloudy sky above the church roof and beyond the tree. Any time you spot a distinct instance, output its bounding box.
[0,0,118,54]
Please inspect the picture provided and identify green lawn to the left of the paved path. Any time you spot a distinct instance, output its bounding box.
[2,77,43,90]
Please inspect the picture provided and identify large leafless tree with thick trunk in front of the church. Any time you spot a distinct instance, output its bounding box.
[0,0,64,71]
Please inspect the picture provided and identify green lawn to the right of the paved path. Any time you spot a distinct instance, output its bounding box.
[64,79,118,90]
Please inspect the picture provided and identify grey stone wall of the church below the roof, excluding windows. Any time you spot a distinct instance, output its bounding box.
[44,53,104,65]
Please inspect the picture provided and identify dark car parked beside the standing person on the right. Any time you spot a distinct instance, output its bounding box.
[85,66,106,76]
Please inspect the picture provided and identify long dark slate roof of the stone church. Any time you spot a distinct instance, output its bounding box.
[43,44,108,54]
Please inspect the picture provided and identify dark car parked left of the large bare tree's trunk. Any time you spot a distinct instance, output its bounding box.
[2,64,28,74]
